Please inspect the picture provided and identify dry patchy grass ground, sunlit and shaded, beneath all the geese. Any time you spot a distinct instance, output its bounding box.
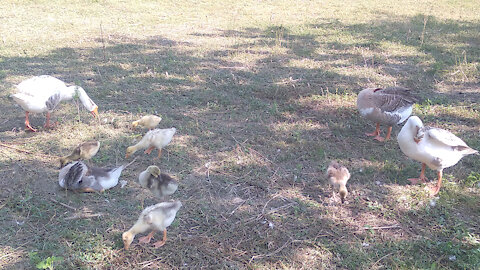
[0,0,480,269]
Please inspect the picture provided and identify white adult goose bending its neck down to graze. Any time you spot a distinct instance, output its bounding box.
[11,75,98,132]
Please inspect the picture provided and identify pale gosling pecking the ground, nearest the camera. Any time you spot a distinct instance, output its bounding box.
[122,201,182,249]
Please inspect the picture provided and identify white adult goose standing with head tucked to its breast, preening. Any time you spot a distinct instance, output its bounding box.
[397,116,478,195]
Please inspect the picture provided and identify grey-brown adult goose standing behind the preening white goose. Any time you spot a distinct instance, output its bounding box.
[357,86,418,142]
